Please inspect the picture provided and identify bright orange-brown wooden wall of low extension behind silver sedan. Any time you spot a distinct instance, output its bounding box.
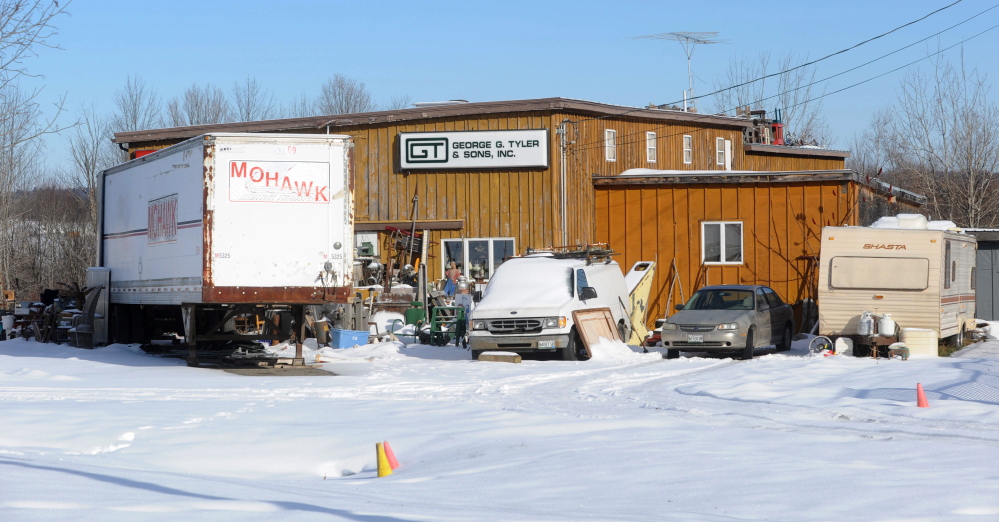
[595,181,856,326]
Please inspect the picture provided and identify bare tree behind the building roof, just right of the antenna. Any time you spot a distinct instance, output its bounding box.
[714,51,830,144]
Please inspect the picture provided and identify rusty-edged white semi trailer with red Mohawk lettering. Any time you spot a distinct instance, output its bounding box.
[96,133,353,364]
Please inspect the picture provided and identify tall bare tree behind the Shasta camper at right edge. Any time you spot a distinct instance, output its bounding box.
[866,51,999,227]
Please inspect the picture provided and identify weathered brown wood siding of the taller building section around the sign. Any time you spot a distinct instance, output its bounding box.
[129,107,842,279]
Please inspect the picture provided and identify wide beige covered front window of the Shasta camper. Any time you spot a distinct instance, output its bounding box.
[829,257,930,290]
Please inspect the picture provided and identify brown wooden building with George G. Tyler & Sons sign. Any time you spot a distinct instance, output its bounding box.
[115,98,921,330]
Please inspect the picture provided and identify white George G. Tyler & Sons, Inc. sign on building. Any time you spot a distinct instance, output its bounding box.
[399,129,548,170]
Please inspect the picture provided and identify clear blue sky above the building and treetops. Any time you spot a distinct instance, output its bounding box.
[28,0,999,164]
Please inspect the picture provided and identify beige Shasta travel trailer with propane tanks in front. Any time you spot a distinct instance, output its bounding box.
[818,214,976,352]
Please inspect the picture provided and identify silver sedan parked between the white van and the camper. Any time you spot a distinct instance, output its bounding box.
[661,285,794,359]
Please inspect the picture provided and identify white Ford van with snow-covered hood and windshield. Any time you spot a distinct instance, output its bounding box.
[468,252,631,361]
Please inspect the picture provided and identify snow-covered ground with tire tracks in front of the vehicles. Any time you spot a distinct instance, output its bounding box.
[0,324,999,521]
